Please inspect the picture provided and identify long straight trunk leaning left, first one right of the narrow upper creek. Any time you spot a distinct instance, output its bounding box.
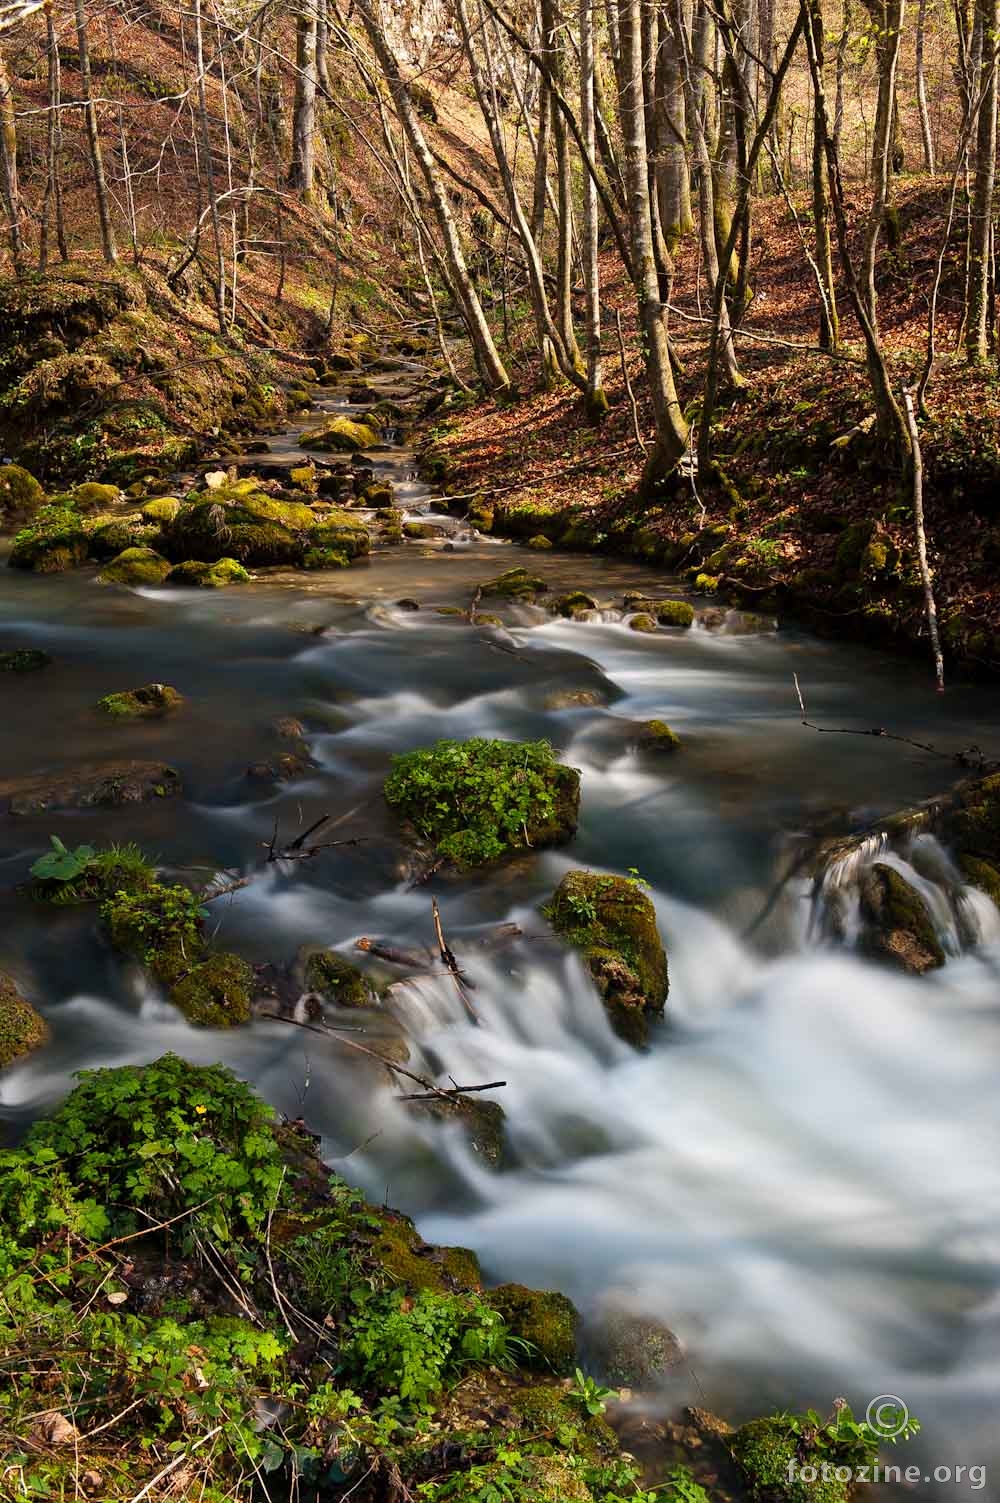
[356,0,510,392]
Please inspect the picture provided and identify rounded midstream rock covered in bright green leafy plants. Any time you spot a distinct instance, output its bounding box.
[385,736,580,867]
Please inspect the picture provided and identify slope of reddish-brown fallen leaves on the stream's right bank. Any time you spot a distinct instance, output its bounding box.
[429,177,1000,675]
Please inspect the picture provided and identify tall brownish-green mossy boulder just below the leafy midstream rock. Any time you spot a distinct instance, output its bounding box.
[543,872,669,1046]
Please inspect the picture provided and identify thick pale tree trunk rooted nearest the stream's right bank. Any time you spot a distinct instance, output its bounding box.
[618,0,689,487]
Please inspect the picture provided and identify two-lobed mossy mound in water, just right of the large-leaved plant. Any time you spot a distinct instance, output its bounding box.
[101,881,254,1028]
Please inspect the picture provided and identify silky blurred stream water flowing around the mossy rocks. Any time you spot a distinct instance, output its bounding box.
[0,393,1000,1497]
